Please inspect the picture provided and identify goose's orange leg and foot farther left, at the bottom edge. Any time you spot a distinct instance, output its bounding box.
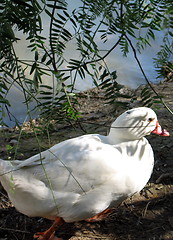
[34,217,65,240]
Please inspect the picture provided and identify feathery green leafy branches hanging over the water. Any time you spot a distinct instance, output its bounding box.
[0,0,173,125]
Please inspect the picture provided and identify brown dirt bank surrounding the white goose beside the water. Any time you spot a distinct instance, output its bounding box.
[0,82,173,240]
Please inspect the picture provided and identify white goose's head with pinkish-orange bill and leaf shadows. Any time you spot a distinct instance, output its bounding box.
[108,107,169,144]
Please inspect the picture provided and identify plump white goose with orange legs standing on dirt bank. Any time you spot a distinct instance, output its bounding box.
[0,107,169,240]
